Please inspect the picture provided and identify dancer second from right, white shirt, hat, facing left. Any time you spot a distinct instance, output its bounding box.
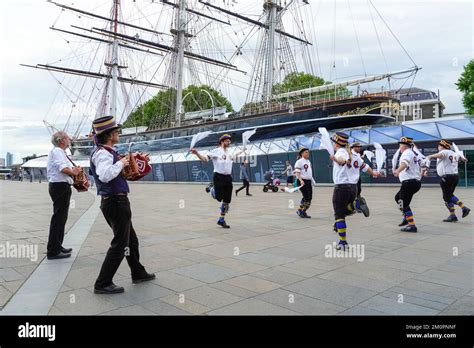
[393,136,423,232]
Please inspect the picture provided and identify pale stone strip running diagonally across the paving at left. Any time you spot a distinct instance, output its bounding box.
[0,192,100,315]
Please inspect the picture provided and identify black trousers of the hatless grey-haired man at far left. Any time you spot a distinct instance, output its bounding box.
[47,182,72,256]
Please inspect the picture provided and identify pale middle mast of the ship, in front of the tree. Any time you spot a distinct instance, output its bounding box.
[176,0,186,127]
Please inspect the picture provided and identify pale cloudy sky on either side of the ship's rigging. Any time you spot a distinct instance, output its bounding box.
[0,0,474,163]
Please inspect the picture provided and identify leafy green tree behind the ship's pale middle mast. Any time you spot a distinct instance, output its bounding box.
[124,85,234,128]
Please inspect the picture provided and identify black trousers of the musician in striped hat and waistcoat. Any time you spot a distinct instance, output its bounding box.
[95,195,146,287]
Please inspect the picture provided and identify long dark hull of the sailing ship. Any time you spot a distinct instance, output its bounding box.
[72,96,398,157]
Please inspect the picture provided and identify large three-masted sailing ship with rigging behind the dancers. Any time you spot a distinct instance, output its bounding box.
[25,0,420,158]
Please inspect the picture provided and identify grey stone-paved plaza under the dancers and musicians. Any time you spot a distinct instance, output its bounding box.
[0,182,474,315]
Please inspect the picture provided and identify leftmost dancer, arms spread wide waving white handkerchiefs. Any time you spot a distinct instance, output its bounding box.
[191,134,245,228]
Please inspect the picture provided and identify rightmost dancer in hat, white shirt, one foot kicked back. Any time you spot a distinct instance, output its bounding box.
[426,139,471,222]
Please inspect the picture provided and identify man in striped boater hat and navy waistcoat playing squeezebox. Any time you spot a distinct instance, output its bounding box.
[90,116,155,294]
